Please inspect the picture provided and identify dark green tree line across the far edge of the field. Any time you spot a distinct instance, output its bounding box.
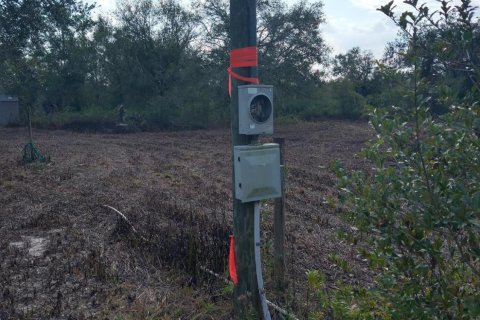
[0,0,479,129]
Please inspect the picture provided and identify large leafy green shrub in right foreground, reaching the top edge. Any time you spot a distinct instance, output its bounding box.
[330,0,480,319]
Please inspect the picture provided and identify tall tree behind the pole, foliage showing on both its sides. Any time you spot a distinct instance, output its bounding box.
[197,0,329,116]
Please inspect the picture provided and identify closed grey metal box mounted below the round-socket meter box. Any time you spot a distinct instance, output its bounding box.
[233,143,282,202]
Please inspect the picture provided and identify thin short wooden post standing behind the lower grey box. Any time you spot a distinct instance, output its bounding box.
[273,138,286,293]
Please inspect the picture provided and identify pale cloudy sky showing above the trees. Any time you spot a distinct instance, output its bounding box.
[91,0,480,58]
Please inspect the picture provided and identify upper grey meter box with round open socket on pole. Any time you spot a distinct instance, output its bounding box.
[238,85,273,135]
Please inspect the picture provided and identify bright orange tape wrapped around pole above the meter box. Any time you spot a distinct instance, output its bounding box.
[227,47,260,96]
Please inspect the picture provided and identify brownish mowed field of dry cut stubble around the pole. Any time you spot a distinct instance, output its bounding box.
[0,121,373,320]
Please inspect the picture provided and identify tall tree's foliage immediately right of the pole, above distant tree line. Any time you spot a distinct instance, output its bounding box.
[258,1,329,115]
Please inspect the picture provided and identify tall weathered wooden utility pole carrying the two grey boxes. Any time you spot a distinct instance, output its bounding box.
[230,0,261,319]
